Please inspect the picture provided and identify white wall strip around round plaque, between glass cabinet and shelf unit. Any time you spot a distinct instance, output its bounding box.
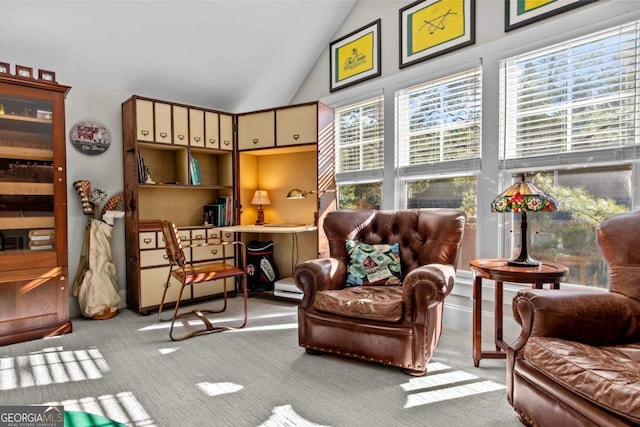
[65,84,131,317]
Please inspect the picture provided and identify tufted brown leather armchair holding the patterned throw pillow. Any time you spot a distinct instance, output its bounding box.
[293,209,466,376]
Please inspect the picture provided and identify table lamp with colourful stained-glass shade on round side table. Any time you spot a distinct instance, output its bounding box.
[491,174,558,267]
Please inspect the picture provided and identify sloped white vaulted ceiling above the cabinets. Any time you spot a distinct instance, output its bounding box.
[0,0,356,112]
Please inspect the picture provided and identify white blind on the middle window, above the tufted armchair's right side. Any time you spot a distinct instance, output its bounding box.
[397,67,481,167]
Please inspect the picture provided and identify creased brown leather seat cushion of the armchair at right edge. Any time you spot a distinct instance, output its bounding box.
[524,337,640,423]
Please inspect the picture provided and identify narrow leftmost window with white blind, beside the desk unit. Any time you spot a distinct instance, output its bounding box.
[335,96,384,209]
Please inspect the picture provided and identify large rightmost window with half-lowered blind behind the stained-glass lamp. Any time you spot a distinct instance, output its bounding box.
[500,23,640,287]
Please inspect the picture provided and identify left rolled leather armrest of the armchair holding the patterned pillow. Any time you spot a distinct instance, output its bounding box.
[293,258,347,307]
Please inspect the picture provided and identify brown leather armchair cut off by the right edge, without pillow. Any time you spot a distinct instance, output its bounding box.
[507,211,640,426]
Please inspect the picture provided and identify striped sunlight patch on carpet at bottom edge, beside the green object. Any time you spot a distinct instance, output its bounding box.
[42,391,157,427]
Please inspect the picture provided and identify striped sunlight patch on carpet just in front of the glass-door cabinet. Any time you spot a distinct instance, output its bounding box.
[0,347,111,390]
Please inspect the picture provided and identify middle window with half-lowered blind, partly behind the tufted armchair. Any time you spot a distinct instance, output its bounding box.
[396,68,482,270]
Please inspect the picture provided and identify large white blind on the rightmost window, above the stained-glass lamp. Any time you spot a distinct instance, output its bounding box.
[500,22,638,163]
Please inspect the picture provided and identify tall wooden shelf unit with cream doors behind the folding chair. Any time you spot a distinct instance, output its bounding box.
[122,96,236,314]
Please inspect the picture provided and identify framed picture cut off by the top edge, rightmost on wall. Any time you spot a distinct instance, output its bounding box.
[504,0,597,32]
